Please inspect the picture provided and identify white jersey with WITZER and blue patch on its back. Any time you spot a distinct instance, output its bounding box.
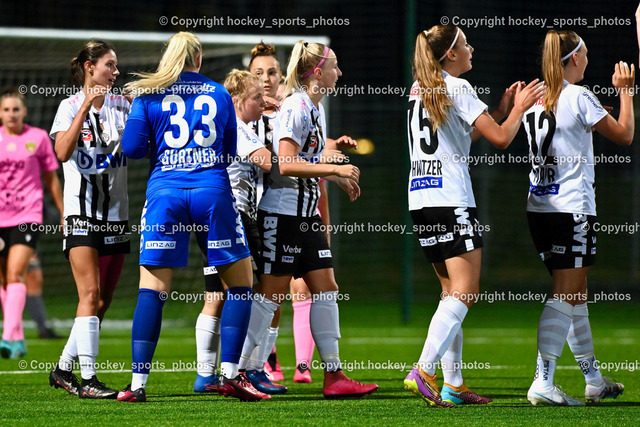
[407,71,487,210]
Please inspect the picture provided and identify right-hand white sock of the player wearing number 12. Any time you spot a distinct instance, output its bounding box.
[567,303,604,385]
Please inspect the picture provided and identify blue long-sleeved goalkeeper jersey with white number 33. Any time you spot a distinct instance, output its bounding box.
[122,72,237,195]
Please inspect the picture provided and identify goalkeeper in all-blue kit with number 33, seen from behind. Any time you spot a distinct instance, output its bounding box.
[118,32,269,402]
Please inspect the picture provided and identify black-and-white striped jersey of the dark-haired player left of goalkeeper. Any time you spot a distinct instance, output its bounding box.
[49,91,131,221]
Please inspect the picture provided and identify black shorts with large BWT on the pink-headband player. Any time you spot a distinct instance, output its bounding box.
[258,210,333,279]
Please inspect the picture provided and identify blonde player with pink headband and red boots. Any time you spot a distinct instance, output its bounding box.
[242,40,378,399]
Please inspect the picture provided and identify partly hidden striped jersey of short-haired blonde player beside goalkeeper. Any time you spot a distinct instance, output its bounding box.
[227,117,264,220]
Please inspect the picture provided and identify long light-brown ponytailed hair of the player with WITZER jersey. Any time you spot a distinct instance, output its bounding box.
[413,25,458,133]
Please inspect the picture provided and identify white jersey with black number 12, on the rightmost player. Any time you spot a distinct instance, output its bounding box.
[522,80,607,215]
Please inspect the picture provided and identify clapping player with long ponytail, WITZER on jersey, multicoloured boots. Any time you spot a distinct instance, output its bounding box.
[404,25,543,407]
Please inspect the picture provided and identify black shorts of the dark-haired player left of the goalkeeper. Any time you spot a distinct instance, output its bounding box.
[62,215,131,259]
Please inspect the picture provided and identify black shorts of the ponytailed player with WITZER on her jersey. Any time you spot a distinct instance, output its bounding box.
[411,207,482,263]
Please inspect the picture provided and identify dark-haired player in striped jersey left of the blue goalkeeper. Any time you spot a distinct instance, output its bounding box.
[49,40,130,399]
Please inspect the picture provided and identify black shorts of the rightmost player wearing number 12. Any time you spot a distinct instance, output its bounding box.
[527,212,596,273]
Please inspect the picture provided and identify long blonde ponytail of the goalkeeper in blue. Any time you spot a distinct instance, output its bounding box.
[125,31,202,96]
